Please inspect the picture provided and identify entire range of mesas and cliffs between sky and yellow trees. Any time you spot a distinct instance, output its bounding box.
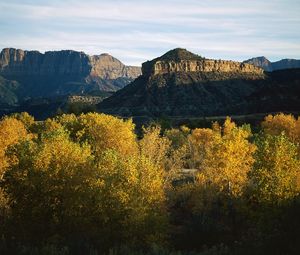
[0,48,300,119]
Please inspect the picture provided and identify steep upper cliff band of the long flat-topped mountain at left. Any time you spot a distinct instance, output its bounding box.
[0,48,141,79]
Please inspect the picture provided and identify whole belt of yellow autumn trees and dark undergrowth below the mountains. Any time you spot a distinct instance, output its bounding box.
[0,113,300,254]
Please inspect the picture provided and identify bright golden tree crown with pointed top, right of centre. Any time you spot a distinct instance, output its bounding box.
[191,119,256,196]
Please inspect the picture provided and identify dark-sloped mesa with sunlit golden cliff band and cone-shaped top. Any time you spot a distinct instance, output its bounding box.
[98,49,290,118]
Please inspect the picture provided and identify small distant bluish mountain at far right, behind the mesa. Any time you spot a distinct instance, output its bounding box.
[244,57,300,72]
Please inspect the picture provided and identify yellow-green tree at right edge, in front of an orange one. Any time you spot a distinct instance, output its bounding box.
[250,133,300,204]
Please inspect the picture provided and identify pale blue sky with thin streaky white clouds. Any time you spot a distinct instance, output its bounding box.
[0,0,300,65]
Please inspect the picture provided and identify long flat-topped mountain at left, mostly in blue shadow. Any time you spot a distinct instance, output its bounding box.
[0,48,141,104]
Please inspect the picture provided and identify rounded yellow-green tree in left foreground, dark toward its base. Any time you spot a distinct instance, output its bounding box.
[3,128,92,242]
